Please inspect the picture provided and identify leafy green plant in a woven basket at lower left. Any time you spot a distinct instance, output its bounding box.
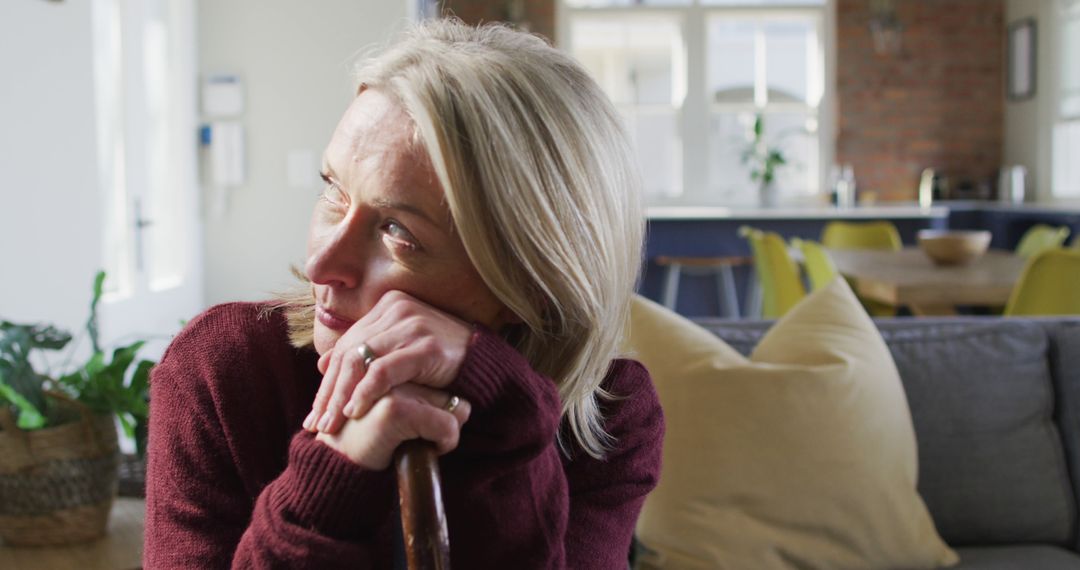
[0,272,153,545]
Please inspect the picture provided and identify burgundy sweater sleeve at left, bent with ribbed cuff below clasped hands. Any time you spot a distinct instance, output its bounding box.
[144,313,395,569]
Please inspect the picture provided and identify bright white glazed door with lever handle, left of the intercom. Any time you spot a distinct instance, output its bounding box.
[93,0,194,300]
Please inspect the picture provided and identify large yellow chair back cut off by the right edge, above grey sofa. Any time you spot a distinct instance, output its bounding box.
[1004,248,1080,316]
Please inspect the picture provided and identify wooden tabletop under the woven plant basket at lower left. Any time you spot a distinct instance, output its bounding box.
[0,498,146,570]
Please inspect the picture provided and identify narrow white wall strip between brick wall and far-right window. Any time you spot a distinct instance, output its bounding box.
[1004,0,1061,201]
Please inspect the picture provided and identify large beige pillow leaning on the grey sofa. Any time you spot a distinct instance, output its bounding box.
[630,280,957,570]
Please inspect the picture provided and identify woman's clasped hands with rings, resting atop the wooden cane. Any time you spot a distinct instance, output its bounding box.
[303,291,472,471]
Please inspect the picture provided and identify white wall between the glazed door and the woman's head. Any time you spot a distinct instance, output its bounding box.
[199,0,409,304]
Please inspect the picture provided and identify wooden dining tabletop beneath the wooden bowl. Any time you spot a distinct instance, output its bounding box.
[828,247,1026,315]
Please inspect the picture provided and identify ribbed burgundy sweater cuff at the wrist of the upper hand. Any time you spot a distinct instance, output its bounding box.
[447,325,528,409]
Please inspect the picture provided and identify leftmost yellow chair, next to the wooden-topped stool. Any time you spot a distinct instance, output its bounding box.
[739,226,807,318]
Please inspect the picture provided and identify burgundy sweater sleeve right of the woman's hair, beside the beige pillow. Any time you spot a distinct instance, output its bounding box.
[564,361,664,570]
